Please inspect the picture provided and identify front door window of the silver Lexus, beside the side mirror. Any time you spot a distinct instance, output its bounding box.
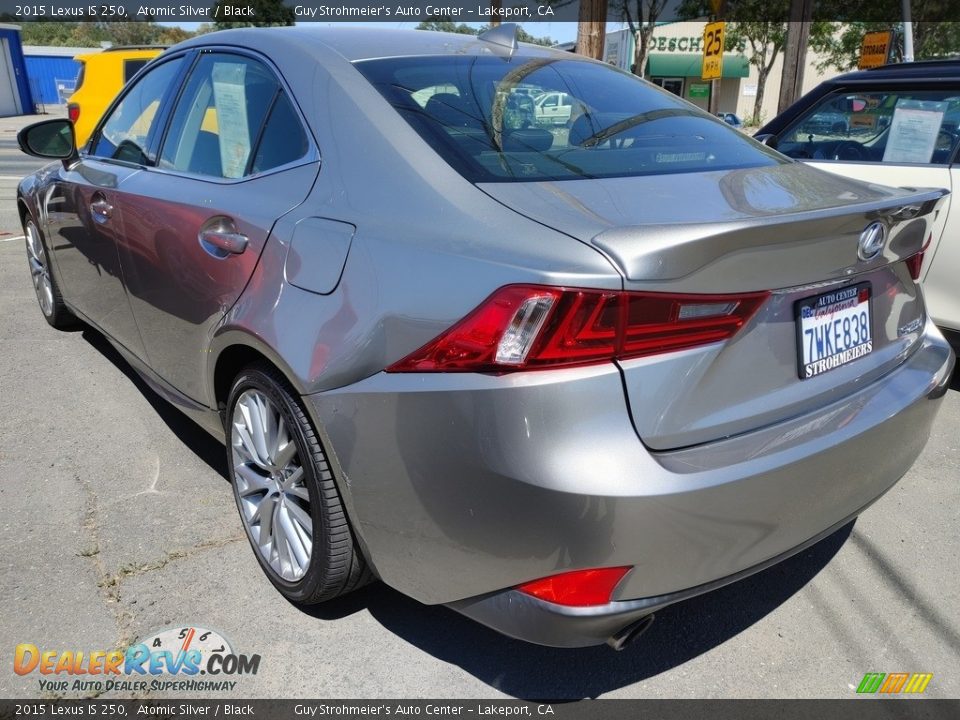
[90,58,183,165]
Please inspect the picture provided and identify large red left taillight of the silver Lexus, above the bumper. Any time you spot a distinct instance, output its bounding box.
[387,285,769,372]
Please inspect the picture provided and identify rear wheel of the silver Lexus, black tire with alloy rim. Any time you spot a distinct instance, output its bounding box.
[226,365,372,605]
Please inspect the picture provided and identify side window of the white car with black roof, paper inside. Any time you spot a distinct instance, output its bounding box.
[777,89,960,165]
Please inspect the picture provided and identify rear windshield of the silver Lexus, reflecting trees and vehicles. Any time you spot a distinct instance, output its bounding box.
[356,56,781,182]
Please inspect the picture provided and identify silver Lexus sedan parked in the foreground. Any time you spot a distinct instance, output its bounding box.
[17,26,954,648]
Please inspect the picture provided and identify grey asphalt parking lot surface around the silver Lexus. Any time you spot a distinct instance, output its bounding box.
[0,112,960,699]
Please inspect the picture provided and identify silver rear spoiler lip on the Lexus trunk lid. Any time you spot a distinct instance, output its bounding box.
[591,189,950,292]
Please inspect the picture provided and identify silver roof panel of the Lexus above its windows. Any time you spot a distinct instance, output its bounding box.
[174,23,574,62]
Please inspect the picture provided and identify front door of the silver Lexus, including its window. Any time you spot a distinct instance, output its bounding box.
[42,54,181,357]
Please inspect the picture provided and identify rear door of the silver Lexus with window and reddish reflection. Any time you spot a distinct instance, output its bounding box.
[109,51,319,401]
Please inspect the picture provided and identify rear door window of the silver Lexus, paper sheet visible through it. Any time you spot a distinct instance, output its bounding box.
[158,53,292,179]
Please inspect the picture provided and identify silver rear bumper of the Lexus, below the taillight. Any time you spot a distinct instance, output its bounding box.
[306,324,954,646]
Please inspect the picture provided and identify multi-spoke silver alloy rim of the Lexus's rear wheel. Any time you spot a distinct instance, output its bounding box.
[230,389,313,582]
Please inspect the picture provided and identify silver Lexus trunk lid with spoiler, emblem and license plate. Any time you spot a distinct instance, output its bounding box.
[482,163,947,450]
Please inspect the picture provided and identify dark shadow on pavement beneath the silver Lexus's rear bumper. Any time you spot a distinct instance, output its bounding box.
[301,521,855,700]
